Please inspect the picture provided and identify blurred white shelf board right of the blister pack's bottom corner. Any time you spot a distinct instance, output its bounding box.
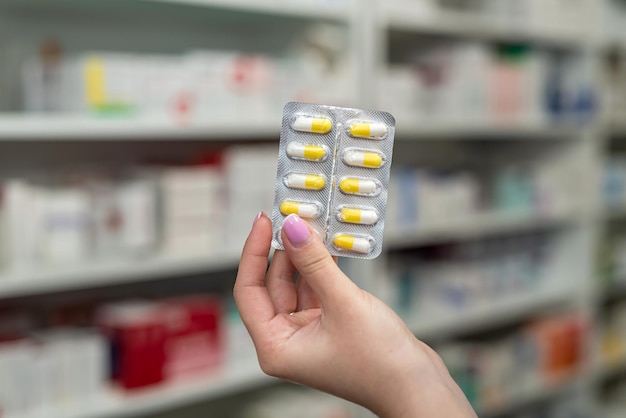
[385,212,583,249]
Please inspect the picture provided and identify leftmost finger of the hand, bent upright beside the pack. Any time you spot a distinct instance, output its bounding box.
[233,213,274,340]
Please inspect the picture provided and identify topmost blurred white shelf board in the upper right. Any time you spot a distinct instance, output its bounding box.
[383,2,601,49]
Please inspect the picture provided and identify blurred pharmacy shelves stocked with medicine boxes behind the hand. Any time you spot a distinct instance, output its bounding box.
[0,0,626,418]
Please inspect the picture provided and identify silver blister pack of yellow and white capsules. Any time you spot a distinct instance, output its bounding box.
[272,102,395,259]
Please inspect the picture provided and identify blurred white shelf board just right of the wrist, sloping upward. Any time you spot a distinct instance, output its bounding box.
[407,288,579,341]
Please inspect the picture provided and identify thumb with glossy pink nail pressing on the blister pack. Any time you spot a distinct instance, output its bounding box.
[282,215,358,305]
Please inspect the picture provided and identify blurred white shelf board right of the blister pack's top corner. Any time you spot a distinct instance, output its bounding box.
[396,121,585,141]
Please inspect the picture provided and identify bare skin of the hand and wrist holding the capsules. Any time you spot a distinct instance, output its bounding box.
[234,214,476,418]
